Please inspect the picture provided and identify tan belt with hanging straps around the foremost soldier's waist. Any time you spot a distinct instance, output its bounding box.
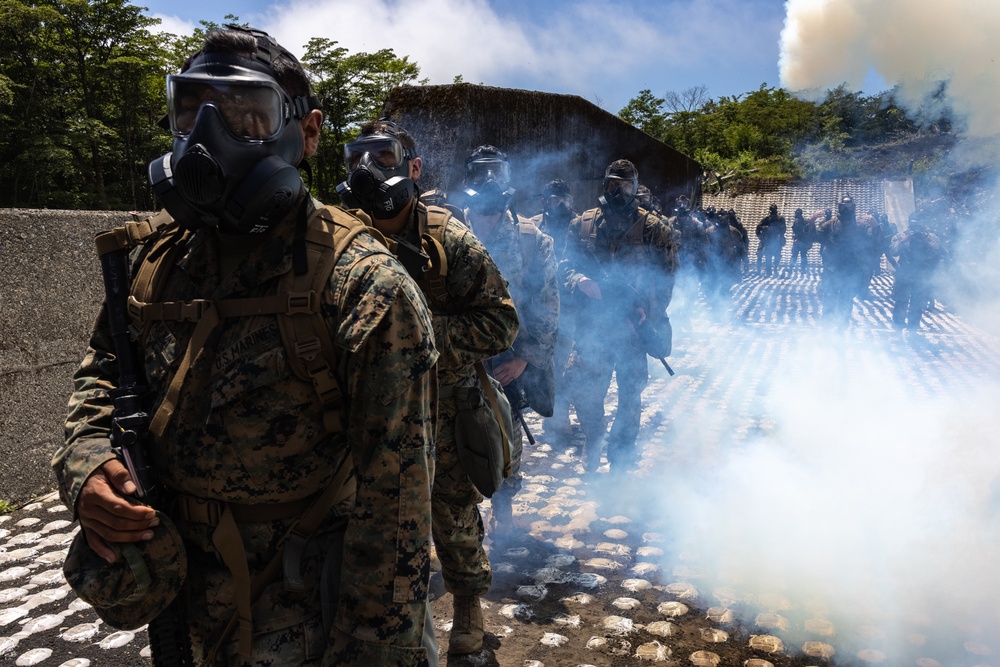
[174,456,357,664]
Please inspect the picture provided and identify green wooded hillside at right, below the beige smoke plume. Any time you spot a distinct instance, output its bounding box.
[618,86,951,187]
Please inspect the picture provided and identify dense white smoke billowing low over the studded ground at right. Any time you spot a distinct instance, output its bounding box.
[606,320,1000,664]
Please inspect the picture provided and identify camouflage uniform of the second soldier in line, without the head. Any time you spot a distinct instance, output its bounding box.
[417,204,518,596]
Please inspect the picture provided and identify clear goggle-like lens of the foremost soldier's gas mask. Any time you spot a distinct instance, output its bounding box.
[167,74,289,141]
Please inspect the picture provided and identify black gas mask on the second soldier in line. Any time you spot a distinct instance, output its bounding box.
[337,132,417,220]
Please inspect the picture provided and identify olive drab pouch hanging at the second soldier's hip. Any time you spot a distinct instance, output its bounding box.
[454,363,514,498]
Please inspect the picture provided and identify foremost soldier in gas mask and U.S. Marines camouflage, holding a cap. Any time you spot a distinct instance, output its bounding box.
[53,26,438,666]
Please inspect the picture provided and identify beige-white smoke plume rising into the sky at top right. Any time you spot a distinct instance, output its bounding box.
[779,0,1000,138]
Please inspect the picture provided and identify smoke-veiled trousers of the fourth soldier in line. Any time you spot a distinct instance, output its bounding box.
[567,335,649,467]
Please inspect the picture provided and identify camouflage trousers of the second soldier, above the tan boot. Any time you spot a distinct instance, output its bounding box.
[431,398,493,596]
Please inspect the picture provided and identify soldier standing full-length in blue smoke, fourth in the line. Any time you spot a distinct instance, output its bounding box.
[560,160,677,472]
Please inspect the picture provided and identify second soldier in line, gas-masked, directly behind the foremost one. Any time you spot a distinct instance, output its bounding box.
[337,119,518,655]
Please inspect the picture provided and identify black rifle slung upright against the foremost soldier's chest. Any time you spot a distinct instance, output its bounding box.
[101,237,194,667]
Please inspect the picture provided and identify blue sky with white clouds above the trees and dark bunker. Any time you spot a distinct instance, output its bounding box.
[135,0,785,112]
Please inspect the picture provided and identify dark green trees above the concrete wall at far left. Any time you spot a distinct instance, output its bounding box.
[0,0,171,208]
